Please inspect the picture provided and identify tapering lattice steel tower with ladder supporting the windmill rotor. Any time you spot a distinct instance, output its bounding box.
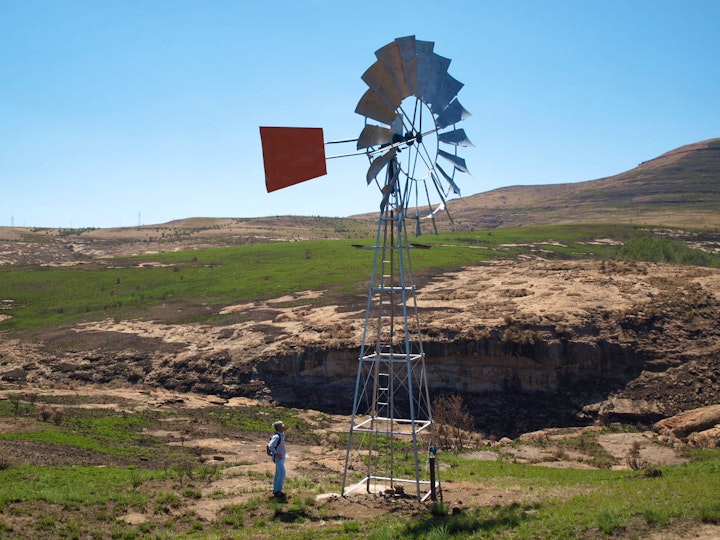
[342,157,439,499]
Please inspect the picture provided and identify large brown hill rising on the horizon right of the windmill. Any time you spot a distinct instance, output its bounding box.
[449,139,720,229]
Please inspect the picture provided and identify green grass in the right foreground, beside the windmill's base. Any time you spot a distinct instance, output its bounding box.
[334,450,720,539]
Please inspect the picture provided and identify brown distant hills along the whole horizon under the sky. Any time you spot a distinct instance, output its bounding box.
[0,139,720,265]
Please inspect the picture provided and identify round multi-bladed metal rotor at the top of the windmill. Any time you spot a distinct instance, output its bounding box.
[355,36,473,235]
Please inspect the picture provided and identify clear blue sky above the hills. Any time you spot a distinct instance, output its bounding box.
[0,0,720,227]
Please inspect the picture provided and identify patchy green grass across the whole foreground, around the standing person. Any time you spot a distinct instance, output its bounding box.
[0,395,720,539]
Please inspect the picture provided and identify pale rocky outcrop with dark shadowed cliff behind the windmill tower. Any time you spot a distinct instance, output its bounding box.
[0,258,720,438]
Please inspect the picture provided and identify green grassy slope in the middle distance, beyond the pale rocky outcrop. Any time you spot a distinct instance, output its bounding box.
[0,224,720,331]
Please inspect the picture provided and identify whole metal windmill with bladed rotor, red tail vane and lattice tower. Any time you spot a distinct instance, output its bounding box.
[260,36,472,500]
